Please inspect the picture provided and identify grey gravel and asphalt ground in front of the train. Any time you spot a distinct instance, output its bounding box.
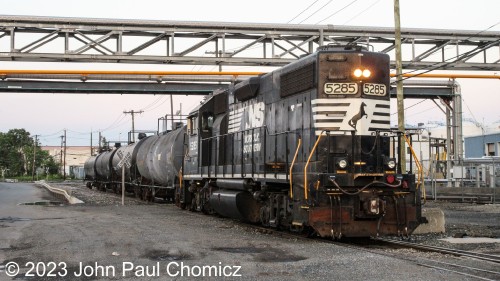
[0,180,496,280]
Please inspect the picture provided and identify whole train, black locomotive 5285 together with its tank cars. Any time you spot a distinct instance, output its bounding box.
[86,46,425,238]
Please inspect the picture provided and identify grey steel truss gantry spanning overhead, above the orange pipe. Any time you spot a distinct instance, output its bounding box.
[0,16,500,71]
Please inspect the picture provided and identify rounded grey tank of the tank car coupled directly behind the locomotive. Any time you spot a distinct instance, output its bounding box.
[137,126,186,187]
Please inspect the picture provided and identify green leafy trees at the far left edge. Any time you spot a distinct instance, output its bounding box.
[0,129,58,177]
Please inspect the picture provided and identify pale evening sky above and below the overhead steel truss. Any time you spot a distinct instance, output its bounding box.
[0,0,500,146]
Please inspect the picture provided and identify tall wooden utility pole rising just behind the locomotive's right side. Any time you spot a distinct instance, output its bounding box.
[394,0,406,173]
